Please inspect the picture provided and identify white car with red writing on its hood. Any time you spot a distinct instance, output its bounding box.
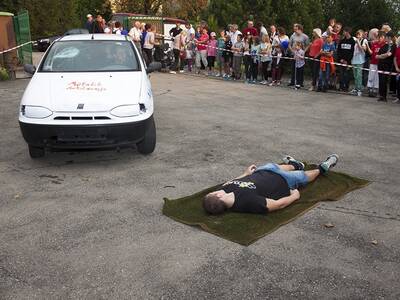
[19,34,161,158]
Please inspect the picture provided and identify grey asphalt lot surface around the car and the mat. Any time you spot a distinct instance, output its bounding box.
[0,74,400,299]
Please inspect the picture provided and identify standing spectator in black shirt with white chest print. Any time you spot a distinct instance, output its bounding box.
[337,27,356,92]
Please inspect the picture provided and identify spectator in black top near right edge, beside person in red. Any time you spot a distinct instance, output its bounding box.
[376,31,396,102]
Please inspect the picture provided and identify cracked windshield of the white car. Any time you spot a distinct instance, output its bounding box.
[39,40,140,72]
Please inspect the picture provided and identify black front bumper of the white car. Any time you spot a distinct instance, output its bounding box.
[19,116,153,149]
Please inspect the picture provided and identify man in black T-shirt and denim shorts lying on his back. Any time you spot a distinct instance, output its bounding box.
[203,154,339,215]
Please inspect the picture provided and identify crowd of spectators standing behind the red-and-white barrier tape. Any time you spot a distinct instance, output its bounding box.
[83,15,400,103]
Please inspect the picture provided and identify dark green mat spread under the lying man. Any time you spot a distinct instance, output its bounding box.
[163,165,369,246]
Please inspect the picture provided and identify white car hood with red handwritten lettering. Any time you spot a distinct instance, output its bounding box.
[23,72,142,112]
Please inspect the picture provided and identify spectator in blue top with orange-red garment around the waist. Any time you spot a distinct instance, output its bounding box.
[317,34,336,92]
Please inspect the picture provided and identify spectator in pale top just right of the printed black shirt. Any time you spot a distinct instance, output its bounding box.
[351,30,368,96]
